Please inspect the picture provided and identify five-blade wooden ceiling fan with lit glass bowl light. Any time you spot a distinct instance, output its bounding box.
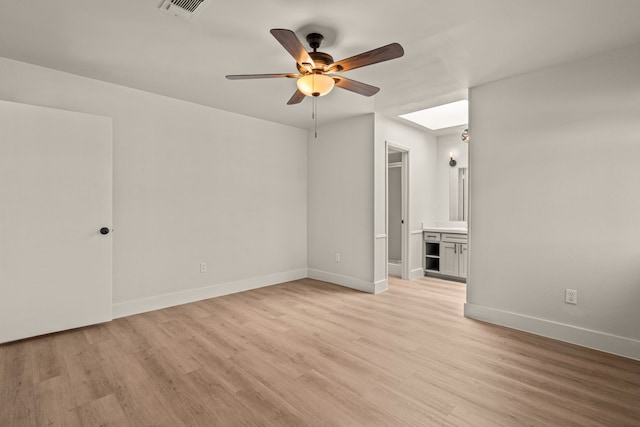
[226,28,404,105]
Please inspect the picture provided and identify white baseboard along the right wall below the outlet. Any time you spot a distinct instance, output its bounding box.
[464,303,640,360]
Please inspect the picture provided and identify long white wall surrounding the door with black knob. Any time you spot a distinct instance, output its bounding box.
[0,58,307,316]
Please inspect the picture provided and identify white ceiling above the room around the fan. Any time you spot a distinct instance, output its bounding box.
[0,0,640,128]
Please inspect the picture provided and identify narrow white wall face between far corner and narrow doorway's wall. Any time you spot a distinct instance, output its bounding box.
[308,114,376,292]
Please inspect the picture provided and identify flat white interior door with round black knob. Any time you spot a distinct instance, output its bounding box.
[0,101,112,342]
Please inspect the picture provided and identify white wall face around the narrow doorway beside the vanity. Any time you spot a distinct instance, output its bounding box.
[374,114,437,283]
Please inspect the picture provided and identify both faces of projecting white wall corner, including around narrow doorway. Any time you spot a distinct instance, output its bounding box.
[308,114,436,292]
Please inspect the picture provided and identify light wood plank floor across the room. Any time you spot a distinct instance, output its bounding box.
[0,278,640,427]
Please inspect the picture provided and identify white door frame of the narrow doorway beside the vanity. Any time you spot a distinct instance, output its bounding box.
[384,141,411,280]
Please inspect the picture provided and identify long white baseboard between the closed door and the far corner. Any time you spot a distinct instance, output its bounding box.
[113,268,307,319]
